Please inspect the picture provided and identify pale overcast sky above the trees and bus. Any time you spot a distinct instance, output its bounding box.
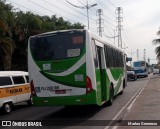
[6,0,160,64]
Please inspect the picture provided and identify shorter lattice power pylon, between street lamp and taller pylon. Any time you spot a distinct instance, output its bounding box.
[97,9,103,37]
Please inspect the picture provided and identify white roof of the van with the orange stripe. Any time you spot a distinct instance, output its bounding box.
[0,71,28,77]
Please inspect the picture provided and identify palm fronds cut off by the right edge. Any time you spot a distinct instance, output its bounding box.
[153,30,160,61]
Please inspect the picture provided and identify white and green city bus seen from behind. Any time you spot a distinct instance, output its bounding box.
[28,29,127,106]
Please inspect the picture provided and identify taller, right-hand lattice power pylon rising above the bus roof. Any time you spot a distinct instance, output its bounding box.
[116,7,123,48]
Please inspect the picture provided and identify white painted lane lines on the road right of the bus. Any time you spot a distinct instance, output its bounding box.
[104,77,150,129]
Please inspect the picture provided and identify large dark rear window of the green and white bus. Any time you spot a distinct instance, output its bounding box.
[30,33,85,61]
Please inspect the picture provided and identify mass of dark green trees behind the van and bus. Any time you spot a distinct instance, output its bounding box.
[0,0,84,71]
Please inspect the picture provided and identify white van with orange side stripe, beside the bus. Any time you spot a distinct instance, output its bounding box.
[0,71,32,113]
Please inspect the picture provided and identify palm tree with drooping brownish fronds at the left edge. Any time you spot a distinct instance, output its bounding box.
[0,0,15,70]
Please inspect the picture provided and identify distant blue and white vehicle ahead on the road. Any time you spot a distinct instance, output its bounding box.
[133,61,148,77]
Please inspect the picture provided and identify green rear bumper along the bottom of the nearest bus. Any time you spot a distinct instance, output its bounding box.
[33,91,97,106]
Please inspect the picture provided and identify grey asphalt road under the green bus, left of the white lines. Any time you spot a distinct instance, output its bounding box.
[0,75,152,129]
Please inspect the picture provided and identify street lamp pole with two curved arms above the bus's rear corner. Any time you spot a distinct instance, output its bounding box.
[66,0,97,30]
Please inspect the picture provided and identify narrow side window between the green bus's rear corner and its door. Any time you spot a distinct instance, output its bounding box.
[92,39,98,68]
